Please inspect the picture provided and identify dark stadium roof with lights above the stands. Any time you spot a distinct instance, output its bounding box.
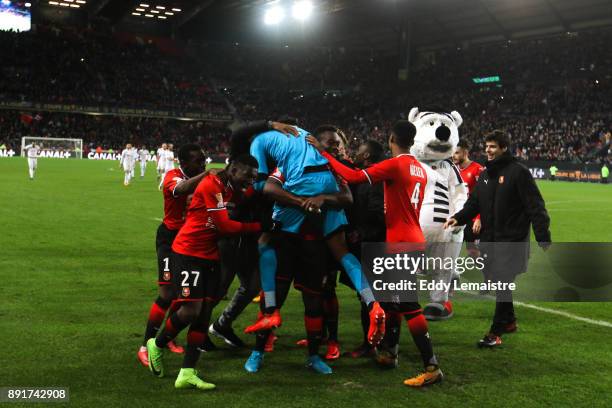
[41,0,612,48]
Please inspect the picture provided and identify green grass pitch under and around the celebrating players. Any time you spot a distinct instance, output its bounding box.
[0,158,612,407]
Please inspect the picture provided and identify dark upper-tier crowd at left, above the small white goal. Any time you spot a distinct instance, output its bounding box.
[0,26,228,113]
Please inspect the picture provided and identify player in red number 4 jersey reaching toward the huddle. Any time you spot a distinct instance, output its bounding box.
[308,120,443,387]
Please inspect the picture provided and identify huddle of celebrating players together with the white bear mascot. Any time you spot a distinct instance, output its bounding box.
[134,111,544,390]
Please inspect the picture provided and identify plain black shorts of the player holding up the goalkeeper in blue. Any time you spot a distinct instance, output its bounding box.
[274,234,329,295]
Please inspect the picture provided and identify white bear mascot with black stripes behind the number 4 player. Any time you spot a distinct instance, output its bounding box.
[408,108,468,320]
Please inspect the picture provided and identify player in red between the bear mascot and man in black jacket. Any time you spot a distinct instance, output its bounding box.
[453,140,484,257]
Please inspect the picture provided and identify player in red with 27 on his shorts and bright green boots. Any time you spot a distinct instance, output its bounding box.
[147,155,261,390]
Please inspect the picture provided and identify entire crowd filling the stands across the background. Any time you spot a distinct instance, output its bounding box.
[0,23,612,162]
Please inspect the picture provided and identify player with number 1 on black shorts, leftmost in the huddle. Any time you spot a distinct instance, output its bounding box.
[138,144,206,366]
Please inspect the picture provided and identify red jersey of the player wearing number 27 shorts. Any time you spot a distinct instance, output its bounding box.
[172,174,261,260]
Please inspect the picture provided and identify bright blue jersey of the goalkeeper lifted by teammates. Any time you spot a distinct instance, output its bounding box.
[250,128,328,190]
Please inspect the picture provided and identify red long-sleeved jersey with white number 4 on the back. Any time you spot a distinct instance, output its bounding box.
[322,153,427,243]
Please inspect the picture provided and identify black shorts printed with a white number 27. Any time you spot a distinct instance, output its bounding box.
[172,252,221,302]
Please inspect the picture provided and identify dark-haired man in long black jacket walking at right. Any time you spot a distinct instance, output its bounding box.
[445,130,551,347]
